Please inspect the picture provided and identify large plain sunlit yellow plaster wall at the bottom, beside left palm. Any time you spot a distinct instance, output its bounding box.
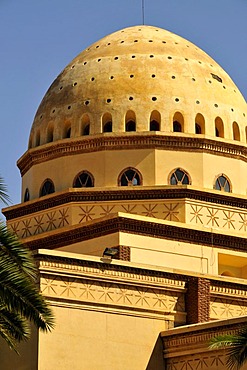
[37,307,167,370]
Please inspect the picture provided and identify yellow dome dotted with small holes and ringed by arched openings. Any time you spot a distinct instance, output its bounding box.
[29,26,247,148]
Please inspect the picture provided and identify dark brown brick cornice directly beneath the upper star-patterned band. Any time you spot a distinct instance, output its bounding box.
[25,215,246,252]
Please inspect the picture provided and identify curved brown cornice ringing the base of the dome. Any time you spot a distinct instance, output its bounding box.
[17,134,247,176]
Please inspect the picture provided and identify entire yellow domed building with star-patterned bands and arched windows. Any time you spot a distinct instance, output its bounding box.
[1,26,247,370]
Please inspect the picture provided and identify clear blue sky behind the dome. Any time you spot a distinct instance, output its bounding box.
[0,0,247,204]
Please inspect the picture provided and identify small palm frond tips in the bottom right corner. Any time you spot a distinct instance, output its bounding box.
[210,327,247,370]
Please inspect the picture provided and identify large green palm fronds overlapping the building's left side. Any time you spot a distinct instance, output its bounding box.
[0,177,53,352]
